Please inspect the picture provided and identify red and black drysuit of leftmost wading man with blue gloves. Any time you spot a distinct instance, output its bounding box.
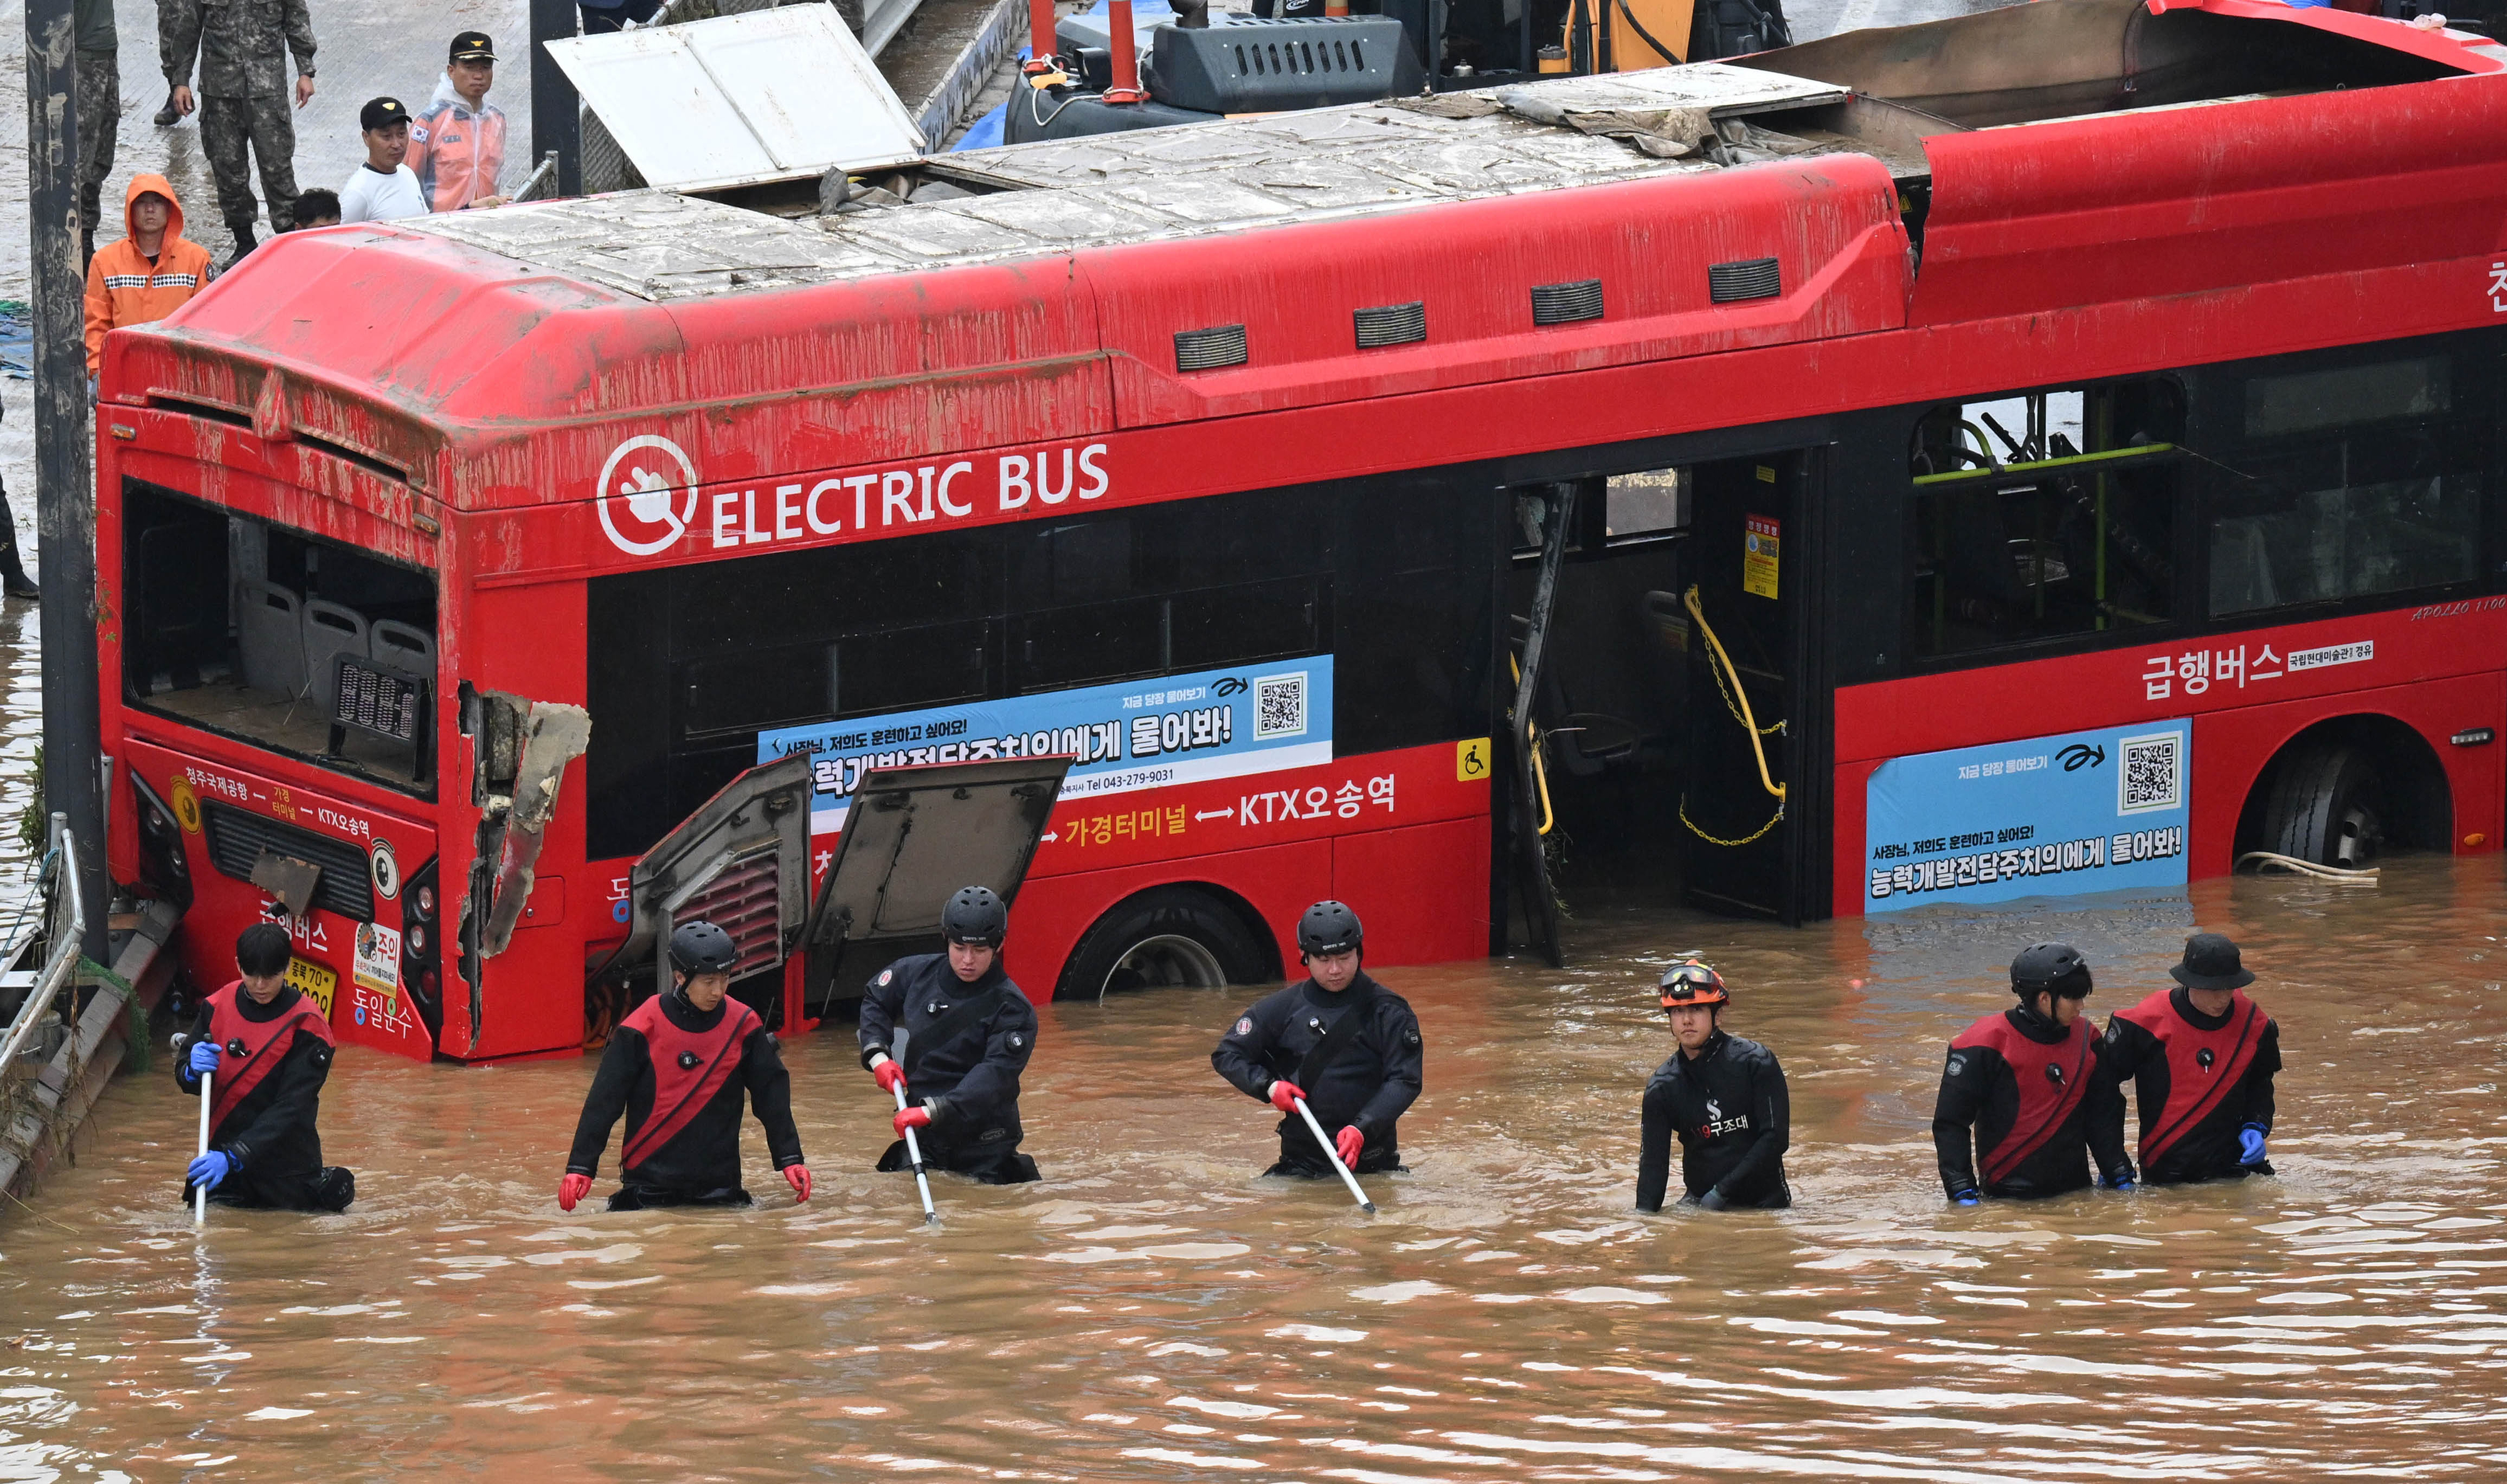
[173,980,356,1211]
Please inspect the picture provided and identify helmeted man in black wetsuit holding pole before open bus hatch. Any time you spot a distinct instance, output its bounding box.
[862,887,1040,1186]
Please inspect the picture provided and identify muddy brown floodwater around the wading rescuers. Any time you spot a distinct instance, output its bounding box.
[0,857,2507,1481]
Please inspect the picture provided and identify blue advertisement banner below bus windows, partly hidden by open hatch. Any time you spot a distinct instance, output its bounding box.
[757,654,1331,835]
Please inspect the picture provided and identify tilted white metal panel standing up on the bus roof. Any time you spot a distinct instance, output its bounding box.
[547,5,923,191]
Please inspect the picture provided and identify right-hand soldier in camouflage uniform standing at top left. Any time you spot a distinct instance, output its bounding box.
[158,0,313,258]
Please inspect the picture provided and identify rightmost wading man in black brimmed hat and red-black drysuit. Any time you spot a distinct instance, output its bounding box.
[2106,933,2281,1186]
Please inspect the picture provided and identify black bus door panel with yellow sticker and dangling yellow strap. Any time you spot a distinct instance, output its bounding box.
[1680,451,1815,925]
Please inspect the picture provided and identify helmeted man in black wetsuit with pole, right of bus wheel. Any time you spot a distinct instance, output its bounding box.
[1211,902,1421,1178]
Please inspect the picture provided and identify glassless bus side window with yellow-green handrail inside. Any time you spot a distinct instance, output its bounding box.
[1905,381,2184,659]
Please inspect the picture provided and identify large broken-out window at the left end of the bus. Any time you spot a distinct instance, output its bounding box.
[123,479,436,792]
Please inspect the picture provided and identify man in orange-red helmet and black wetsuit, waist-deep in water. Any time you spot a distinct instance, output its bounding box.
[1637,958,1793,1211]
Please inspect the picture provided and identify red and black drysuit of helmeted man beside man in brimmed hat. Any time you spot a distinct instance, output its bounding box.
[1933,1008,2133,1201]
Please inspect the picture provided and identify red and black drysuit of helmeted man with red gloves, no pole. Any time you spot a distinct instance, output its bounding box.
[567,990,802,1211]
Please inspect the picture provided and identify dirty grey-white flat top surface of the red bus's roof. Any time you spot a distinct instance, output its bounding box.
[401,63,1848,301]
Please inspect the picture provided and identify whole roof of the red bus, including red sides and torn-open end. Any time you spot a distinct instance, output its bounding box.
[103,0,2507,521]
